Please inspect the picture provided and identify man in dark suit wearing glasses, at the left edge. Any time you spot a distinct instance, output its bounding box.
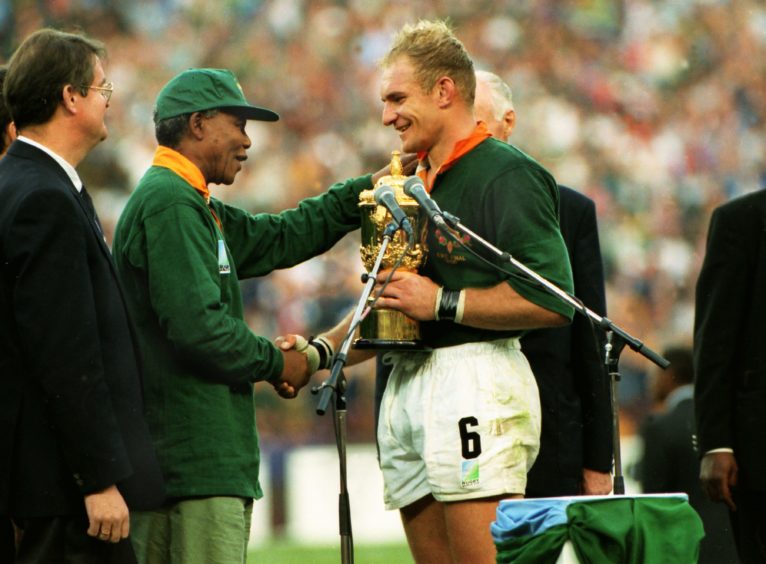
[0,29,163,563]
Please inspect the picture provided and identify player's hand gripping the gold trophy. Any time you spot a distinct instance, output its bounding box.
[376,270,439,321]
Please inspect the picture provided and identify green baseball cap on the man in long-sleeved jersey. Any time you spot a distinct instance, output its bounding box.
[154,69,279,123]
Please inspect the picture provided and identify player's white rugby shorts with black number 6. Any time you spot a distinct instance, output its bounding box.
[377,338,540,509]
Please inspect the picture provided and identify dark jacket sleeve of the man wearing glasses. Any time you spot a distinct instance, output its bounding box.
[8,187,132,494]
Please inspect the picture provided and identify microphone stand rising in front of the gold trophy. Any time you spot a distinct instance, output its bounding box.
[311,222,398,564]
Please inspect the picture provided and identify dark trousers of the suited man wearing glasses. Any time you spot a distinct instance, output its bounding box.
[16,517,136,564]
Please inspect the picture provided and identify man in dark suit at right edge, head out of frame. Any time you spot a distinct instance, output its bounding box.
[694,190,766,562]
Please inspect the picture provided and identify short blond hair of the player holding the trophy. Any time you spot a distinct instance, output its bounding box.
[380,20,476,105]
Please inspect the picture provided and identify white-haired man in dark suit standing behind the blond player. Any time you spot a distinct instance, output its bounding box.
[474,70,613,497]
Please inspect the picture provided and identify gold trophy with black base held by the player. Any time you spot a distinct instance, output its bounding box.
[354,151,427,350]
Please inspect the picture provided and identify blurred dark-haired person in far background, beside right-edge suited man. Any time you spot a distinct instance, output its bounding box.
[639,347,738,564]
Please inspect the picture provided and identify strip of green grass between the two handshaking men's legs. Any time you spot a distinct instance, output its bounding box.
[247,543,413,564]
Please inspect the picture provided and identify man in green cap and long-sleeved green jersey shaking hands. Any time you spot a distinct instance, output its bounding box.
[114,68,400,564]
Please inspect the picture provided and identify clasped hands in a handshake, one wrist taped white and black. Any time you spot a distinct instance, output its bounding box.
[271,335,335,399]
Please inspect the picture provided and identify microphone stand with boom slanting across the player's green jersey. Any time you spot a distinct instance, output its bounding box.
[442,211,670,495]
